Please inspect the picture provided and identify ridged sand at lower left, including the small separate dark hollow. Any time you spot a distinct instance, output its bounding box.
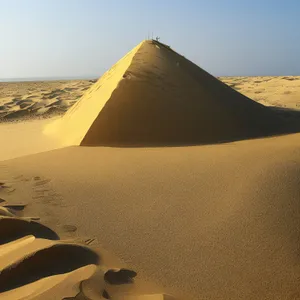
[0,210,171,300]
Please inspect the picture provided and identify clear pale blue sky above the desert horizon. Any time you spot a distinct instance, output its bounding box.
[0,0,300,78]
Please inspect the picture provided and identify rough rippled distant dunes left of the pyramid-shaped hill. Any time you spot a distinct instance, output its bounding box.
[0,80,94,122]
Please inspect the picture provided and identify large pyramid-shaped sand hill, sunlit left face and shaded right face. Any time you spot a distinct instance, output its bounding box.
[46,41,283,145]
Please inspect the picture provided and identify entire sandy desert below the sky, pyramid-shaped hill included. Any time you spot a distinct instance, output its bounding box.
[0,43,300,300]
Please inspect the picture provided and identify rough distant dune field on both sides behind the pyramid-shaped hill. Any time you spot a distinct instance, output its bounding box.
[0,76,300,122]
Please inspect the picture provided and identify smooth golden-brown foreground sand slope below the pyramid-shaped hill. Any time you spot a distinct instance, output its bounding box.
[1,134,300,299]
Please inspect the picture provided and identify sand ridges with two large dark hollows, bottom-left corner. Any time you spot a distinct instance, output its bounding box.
[0,216,100,300]
